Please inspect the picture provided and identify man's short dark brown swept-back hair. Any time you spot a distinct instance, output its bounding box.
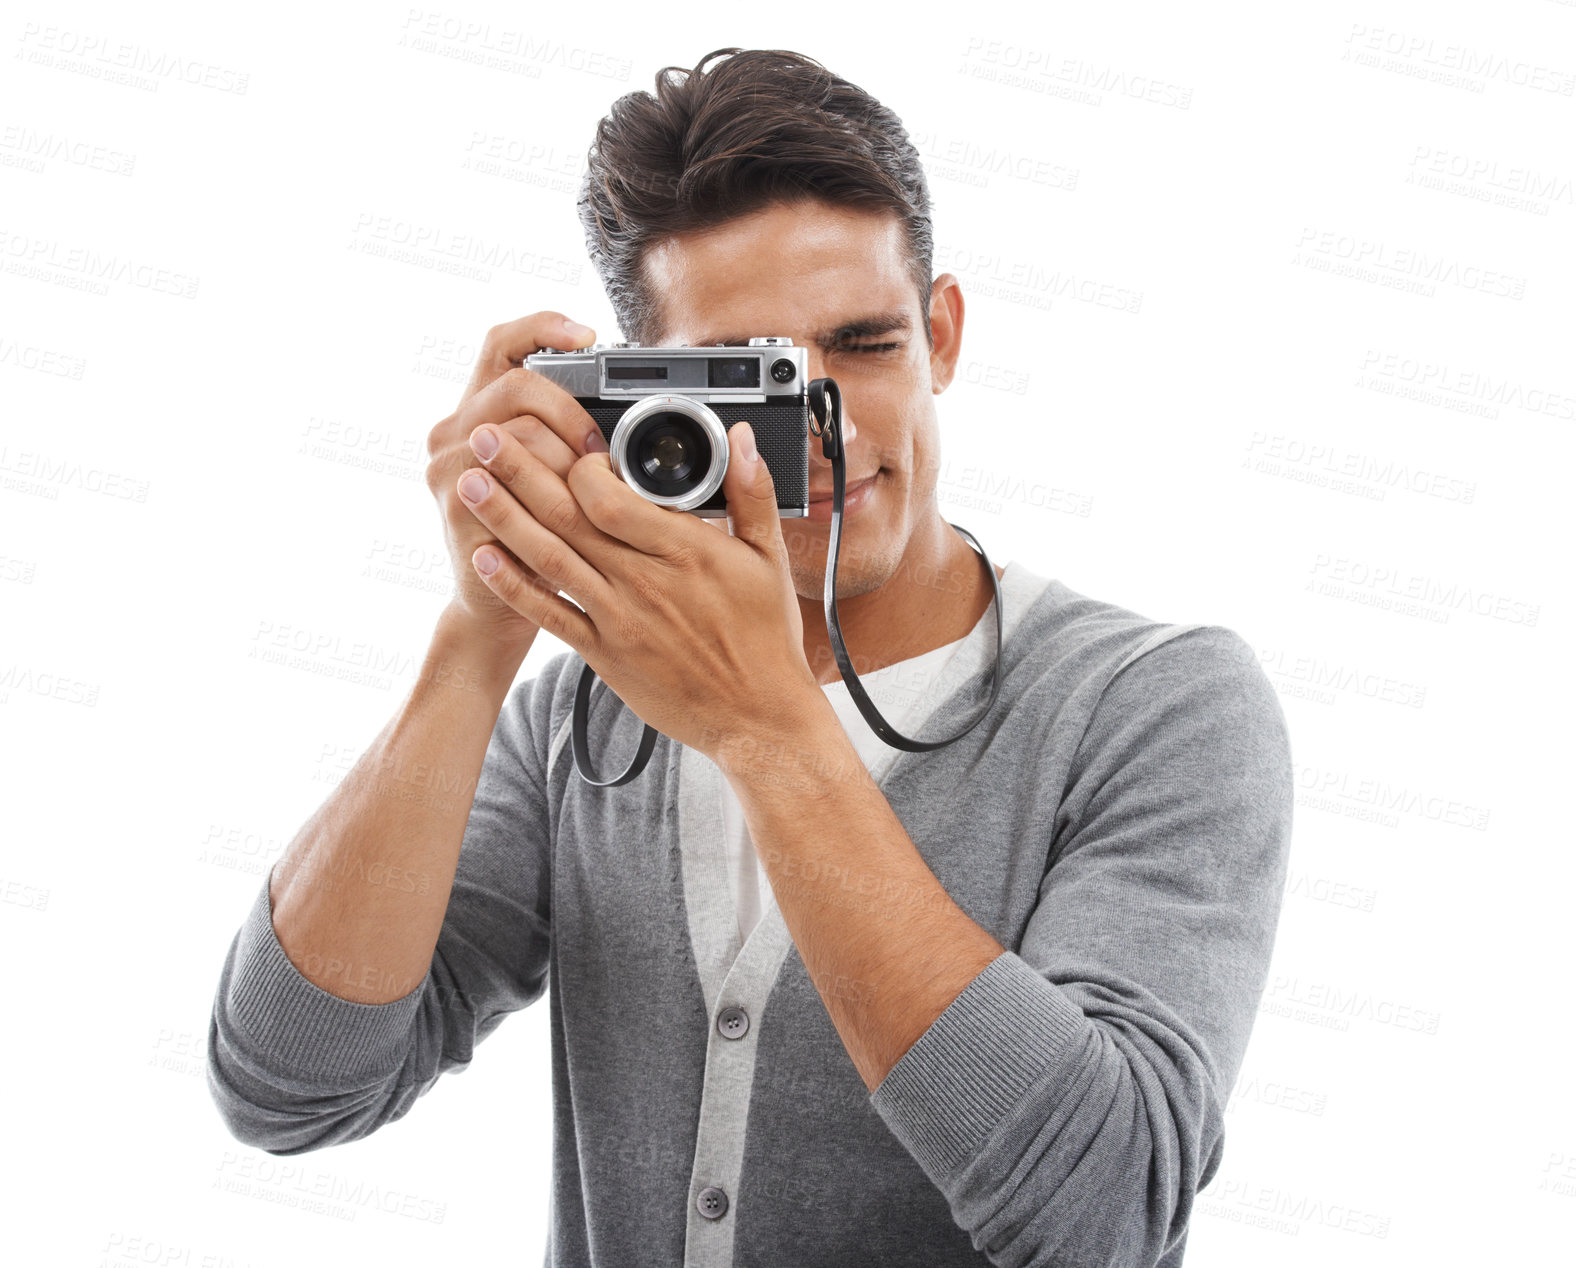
[575,49,935,347]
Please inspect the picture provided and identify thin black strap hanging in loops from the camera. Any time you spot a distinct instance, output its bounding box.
[569,378,1002,788]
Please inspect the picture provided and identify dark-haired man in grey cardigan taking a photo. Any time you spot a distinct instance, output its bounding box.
[208,49,1292,1268]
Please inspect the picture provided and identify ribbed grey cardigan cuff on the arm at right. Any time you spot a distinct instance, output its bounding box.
[870,951,1089,1181]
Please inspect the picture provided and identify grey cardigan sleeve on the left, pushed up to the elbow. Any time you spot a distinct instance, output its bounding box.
[206,654,567,1155]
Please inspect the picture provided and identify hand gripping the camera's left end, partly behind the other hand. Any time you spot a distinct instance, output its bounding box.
[427,312,607,657]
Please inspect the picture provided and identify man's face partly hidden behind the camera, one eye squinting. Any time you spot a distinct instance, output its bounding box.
[645,202,963,602]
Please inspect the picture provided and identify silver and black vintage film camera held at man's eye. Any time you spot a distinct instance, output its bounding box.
[525,336,810,518]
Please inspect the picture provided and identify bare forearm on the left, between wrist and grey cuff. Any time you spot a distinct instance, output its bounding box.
[269,608,525,1003]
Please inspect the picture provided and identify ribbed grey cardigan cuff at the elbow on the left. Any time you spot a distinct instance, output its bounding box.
[229,877,430,1092]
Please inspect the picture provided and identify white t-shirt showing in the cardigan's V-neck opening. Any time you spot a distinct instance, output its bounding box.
[722,626,970,945]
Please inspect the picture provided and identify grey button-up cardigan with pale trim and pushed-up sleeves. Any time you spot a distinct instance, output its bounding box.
[208,565,1292,1268]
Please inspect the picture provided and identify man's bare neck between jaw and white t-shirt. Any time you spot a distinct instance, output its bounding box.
[799,515,1005,687]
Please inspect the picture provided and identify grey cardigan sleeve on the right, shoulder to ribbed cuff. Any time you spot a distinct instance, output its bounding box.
[870,625,1294,1268]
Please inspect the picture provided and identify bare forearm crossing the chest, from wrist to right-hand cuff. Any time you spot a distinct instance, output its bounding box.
[719,698,1004,1090]
